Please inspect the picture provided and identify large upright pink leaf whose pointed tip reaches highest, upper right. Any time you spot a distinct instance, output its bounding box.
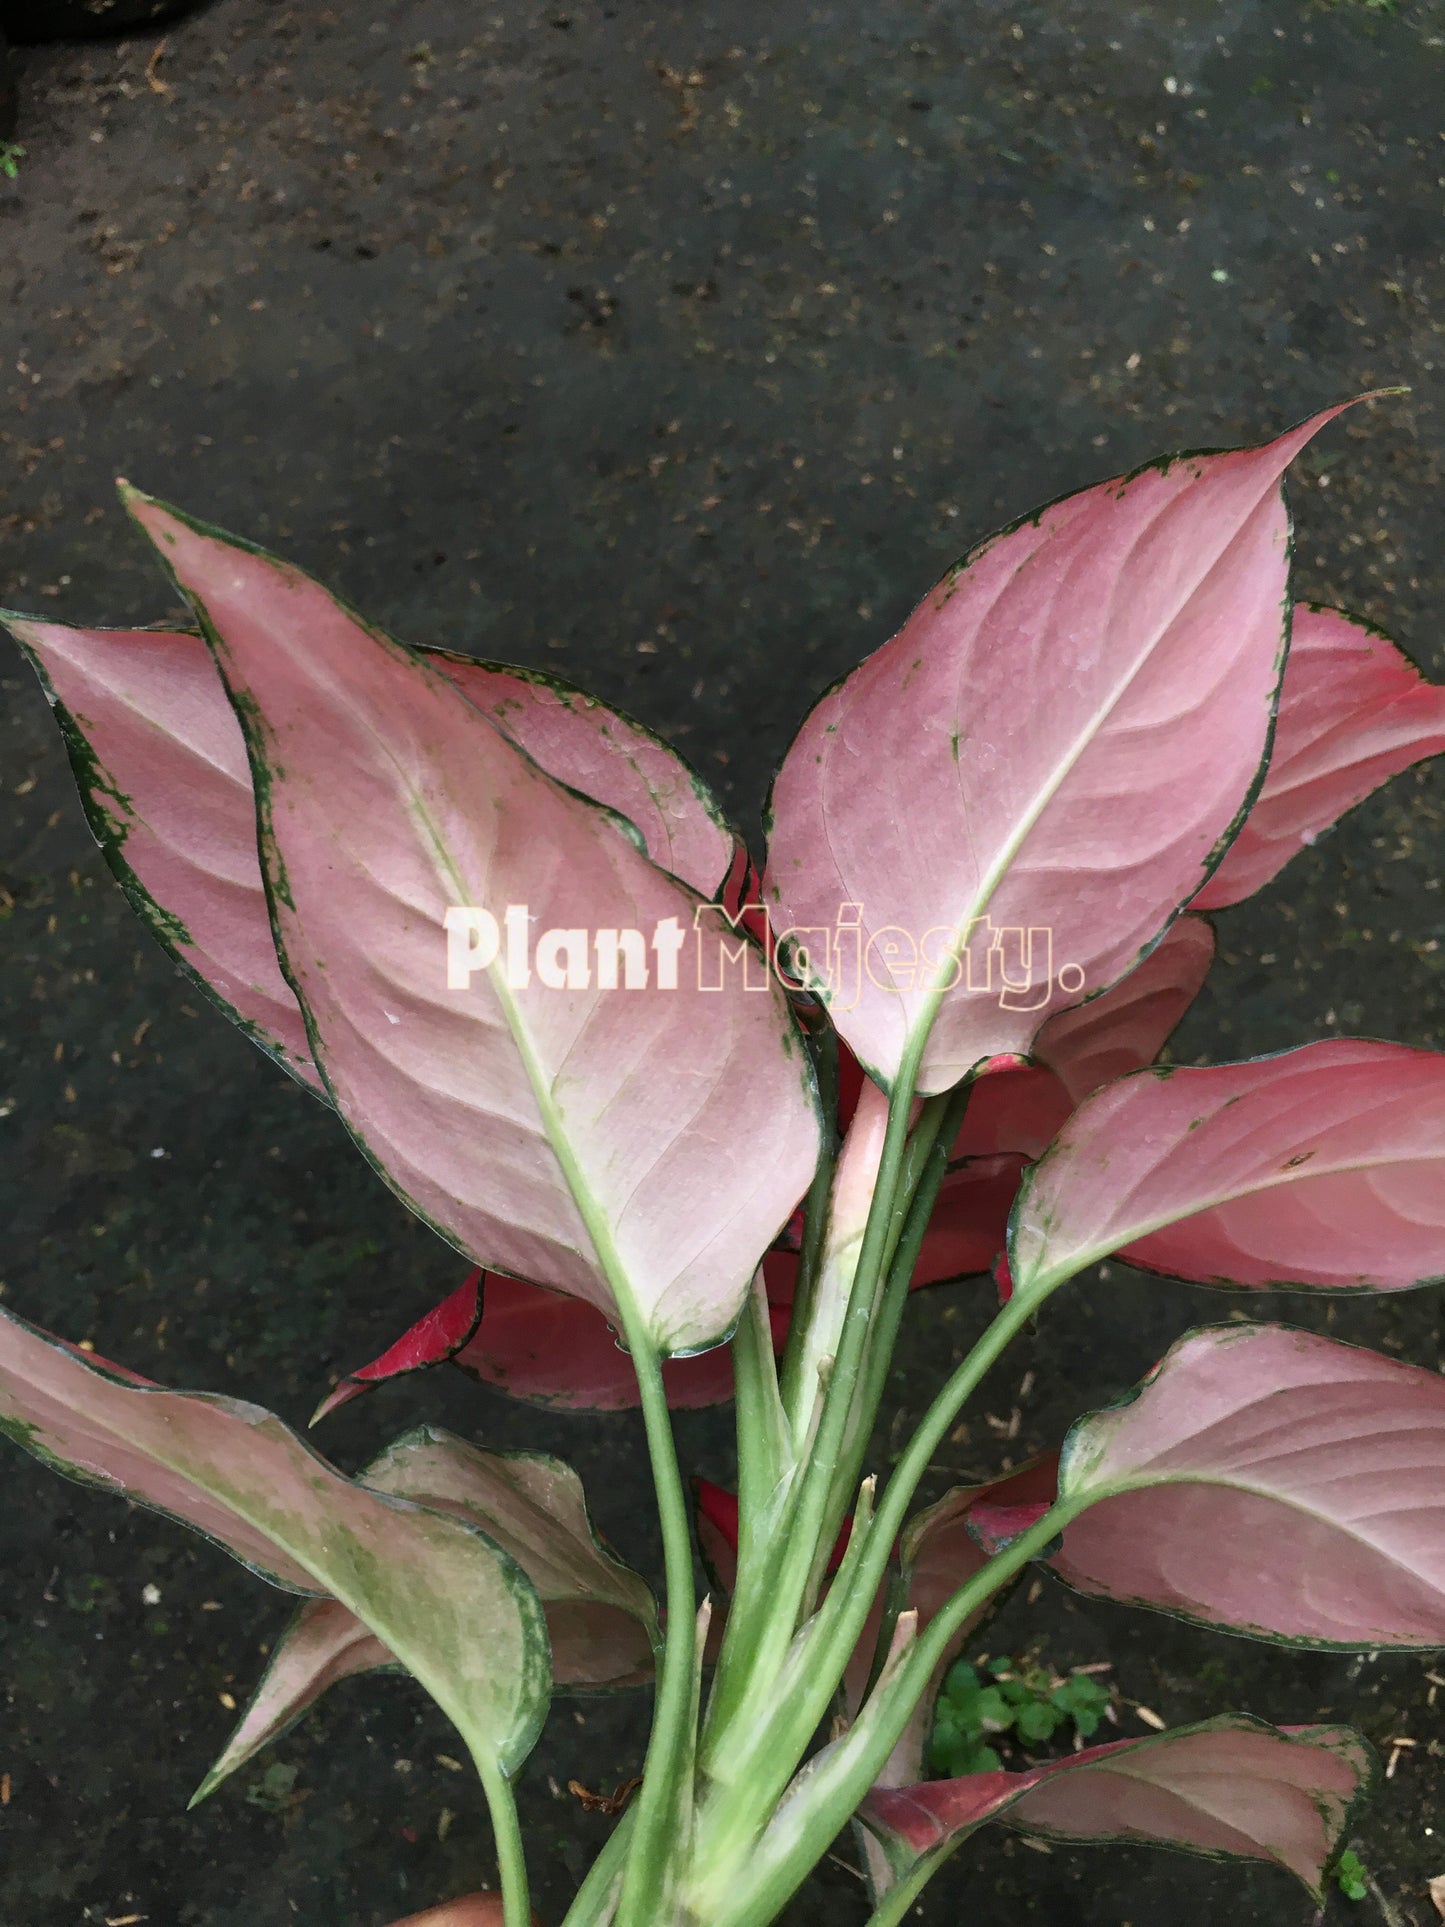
[765,410,1364,1093]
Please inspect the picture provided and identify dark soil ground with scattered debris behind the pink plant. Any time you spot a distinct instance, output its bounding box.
[0,0,1445,1927]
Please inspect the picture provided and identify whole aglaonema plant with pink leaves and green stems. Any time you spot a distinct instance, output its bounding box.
[0,395,1445,1927]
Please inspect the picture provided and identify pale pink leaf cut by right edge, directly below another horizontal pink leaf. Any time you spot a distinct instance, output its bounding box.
[1052,1326,1445,1651]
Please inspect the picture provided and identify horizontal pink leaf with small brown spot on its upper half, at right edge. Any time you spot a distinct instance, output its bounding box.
[1010,1039,1445,1293]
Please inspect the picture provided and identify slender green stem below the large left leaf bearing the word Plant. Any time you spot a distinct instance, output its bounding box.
[612,1345,697,1927]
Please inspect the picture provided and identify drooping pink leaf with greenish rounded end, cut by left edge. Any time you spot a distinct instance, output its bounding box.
[0,1310,551,1771]
